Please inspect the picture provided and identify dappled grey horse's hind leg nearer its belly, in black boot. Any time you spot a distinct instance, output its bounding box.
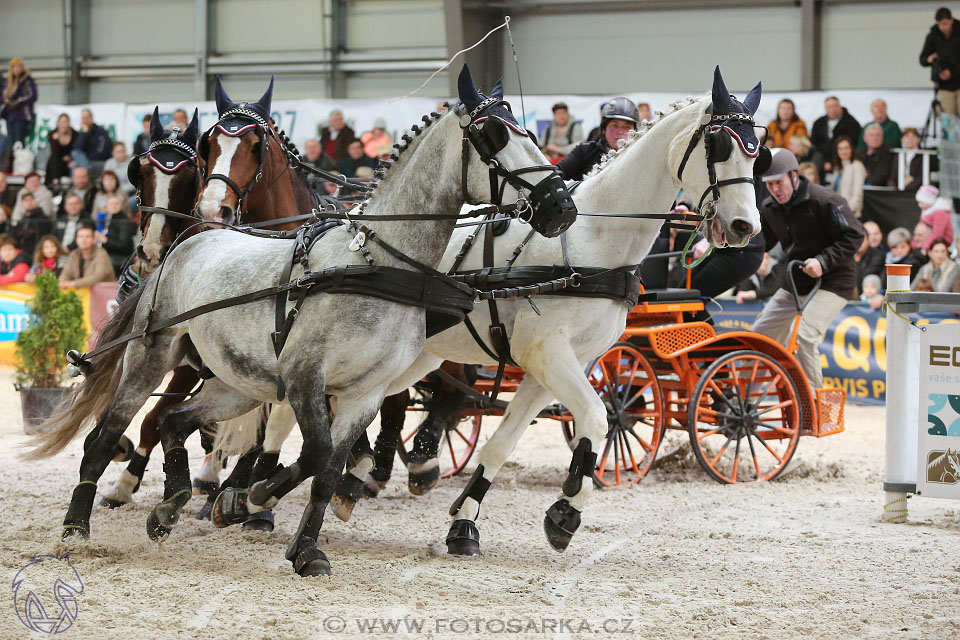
[147,378,259,541]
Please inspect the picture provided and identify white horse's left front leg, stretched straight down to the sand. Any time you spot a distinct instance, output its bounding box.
[446,376,552,556]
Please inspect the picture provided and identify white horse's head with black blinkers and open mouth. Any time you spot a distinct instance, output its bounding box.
[671,67,770,247]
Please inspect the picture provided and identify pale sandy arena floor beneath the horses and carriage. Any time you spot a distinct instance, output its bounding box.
[0,371,960,640]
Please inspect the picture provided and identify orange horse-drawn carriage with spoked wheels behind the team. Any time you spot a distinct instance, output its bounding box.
[399,264,846,486]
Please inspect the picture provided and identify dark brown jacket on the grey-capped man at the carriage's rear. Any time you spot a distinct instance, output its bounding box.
[760,177,864,299]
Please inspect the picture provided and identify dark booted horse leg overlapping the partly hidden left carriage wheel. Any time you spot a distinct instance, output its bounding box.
[407,361,475,496]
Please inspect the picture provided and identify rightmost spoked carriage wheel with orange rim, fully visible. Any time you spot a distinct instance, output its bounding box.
[687,351,800,484]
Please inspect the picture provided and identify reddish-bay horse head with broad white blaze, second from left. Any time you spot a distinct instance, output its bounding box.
[198,78,287,223]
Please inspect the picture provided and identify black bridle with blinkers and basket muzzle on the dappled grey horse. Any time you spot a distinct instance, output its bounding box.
[457,96,577,237]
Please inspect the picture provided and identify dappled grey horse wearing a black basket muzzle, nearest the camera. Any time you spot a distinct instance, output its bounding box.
[27,66,576,575]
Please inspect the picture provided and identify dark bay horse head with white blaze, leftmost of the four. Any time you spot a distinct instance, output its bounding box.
[127,108,203,273]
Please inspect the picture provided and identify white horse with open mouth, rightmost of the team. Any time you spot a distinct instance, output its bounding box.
[326,68,769,555]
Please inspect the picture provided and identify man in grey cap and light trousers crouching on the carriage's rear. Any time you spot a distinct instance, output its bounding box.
[753,149,864,389]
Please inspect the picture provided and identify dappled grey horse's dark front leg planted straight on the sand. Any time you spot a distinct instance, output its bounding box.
[286,390,383,576]
